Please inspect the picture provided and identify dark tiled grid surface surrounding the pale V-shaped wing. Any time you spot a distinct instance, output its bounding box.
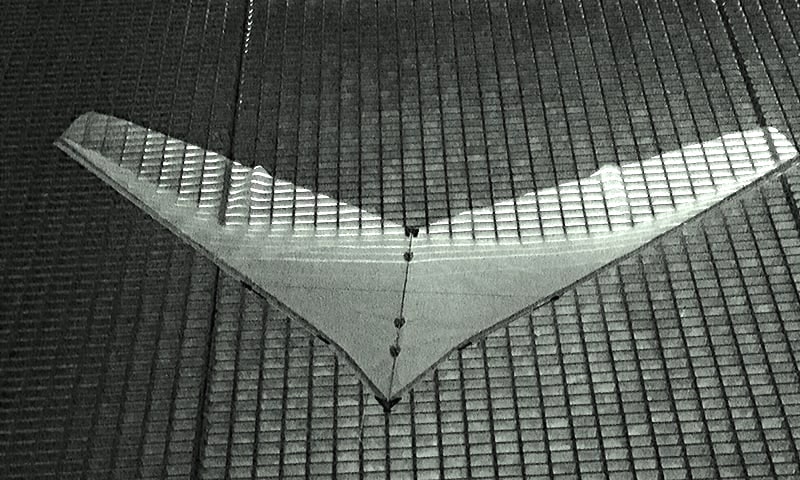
[0,0,800,479]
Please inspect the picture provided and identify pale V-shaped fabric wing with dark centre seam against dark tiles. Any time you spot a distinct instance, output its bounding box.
[56,112,797,402]
